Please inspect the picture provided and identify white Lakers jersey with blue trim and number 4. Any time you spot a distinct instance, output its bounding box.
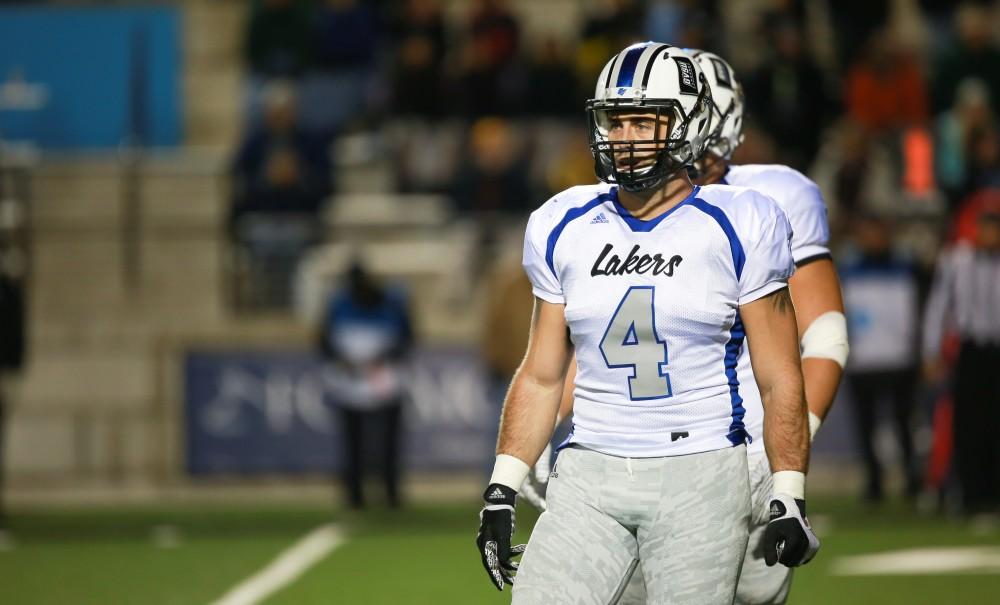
[524,184,794,457]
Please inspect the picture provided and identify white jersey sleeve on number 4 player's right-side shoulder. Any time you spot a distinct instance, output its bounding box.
[739,202,795,305]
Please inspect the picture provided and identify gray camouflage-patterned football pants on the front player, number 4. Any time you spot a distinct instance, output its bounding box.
[512,445,750,605]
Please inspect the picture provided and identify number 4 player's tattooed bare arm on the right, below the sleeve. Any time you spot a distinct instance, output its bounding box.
[740,288,809,473]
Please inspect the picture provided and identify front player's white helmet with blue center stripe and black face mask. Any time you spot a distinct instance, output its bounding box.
[587,42,712,192]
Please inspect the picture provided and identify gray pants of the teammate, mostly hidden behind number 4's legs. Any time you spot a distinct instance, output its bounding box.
[618,451,792,605]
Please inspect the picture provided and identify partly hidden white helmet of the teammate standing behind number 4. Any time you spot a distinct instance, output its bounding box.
[687,48,745,161]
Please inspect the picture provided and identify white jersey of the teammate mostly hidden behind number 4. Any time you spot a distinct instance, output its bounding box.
[722,164,830,451]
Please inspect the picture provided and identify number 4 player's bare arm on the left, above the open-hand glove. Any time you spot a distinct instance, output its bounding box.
[497,298,572,465]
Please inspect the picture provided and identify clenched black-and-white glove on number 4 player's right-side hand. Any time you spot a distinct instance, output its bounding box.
[764,494,819,567]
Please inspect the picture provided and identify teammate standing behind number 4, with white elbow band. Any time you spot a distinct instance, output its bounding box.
[691,50,848,605]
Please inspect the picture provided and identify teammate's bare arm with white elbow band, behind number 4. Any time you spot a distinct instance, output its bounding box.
[788,258,847,432]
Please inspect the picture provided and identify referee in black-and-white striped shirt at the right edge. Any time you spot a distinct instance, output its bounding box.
[923,206,1000,514]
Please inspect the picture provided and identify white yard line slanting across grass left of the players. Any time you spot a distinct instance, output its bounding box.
[211,524,347,605]
